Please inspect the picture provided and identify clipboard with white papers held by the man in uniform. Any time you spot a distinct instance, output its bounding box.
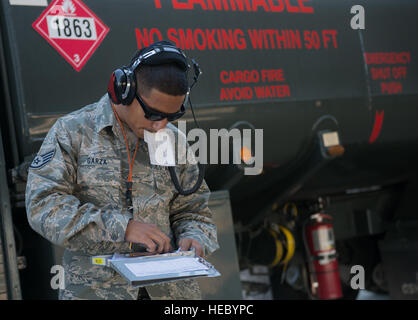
[106,251,221,288]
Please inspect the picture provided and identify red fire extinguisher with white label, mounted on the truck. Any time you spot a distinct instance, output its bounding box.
[304,213,342,299]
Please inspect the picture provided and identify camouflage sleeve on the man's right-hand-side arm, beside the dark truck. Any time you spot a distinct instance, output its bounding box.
[170,165,219,256]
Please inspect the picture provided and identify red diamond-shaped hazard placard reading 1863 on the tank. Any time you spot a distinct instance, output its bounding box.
[32,0,109,71]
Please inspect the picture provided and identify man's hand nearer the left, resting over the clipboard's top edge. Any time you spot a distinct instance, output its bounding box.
[125,220,173,253]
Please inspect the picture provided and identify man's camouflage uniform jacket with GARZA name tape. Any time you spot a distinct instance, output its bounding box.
[26,95,218,299]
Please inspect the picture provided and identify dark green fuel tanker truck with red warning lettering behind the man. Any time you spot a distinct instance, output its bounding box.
[0,0,418,299]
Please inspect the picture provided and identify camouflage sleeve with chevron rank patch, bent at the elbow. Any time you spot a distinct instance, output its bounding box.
[25,119,132,252]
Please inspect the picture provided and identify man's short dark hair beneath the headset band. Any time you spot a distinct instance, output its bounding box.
[135,63,189,96]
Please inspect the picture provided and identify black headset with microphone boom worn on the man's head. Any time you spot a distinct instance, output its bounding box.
[107,41,205,196]
